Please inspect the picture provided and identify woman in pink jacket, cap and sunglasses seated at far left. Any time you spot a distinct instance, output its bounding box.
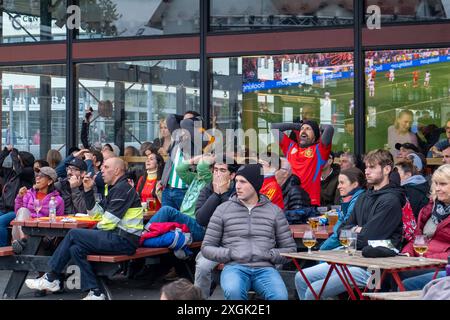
[12,167,64,254]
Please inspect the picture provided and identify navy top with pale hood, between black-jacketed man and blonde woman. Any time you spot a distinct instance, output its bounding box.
[402,175,430,220]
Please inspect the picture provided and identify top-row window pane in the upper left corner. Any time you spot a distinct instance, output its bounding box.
[0,0,66,43]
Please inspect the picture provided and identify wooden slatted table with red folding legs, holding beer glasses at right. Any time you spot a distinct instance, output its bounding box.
[281,250,447,300]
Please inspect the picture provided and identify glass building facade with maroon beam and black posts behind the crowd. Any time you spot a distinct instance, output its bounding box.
[0,0,450,158]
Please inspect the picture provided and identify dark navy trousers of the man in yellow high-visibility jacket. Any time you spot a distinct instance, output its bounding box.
[49,229,136,291]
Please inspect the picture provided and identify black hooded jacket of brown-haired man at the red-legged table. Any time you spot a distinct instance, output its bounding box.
[338,183,406,250]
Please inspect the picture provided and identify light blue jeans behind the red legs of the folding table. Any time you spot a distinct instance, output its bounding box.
[295,263,370,300]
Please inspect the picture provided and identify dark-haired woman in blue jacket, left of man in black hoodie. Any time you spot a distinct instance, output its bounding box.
[320,167,366,250]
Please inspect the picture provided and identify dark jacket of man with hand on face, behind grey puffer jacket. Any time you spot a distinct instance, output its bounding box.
[195,182,235,227]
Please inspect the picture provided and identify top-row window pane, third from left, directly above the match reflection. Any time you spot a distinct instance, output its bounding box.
[210,0,353,31]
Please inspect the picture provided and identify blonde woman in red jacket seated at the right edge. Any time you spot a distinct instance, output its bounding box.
[402,164,450,290]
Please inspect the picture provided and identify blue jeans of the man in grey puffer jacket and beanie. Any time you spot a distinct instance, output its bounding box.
[220,264,288,300]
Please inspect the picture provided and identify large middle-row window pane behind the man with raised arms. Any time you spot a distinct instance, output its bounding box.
[211,52,354,158]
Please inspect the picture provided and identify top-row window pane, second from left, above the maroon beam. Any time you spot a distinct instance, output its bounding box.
[79,0,200,39]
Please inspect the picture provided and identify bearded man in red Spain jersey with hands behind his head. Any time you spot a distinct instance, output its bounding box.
[272,120,334,206]
